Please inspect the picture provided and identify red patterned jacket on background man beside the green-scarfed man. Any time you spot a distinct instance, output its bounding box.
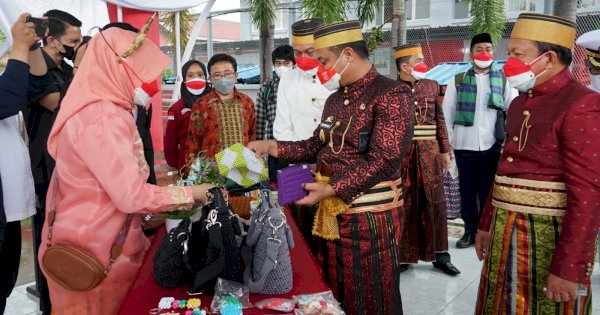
[400,79,450,153]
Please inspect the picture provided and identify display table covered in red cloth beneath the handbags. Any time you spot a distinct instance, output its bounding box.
[119,208,330,315]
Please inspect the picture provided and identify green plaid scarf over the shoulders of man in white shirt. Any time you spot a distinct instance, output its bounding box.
[454,64,504,126]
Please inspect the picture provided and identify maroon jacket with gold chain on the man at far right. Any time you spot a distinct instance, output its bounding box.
[479,68,600,283]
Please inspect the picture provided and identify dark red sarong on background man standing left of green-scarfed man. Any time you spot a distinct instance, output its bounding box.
[400,140,448,263]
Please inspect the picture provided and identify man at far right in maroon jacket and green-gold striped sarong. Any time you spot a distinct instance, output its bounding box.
[475,13,600,314]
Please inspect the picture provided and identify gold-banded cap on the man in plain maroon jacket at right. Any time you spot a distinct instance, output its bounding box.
[510,13,577,49]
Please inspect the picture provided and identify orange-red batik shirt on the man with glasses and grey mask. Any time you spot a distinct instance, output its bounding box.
[185,88,256,166]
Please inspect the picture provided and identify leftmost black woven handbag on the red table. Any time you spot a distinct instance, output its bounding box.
[154,218,192,288]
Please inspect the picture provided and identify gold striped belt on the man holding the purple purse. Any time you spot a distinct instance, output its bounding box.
[343,179,404,214]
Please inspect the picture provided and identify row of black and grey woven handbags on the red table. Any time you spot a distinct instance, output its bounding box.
[154,188,294,294]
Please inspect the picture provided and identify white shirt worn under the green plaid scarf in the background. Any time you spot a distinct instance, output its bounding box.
[442,73,519,151]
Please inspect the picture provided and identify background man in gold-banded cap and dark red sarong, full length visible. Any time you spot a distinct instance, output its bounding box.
[394,43,460,276]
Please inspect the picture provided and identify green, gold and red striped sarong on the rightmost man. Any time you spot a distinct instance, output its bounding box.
[475,209,592,315]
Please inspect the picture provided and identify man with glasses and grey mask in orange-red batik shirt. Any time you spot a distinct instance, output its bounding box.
[185,54,256,167]
